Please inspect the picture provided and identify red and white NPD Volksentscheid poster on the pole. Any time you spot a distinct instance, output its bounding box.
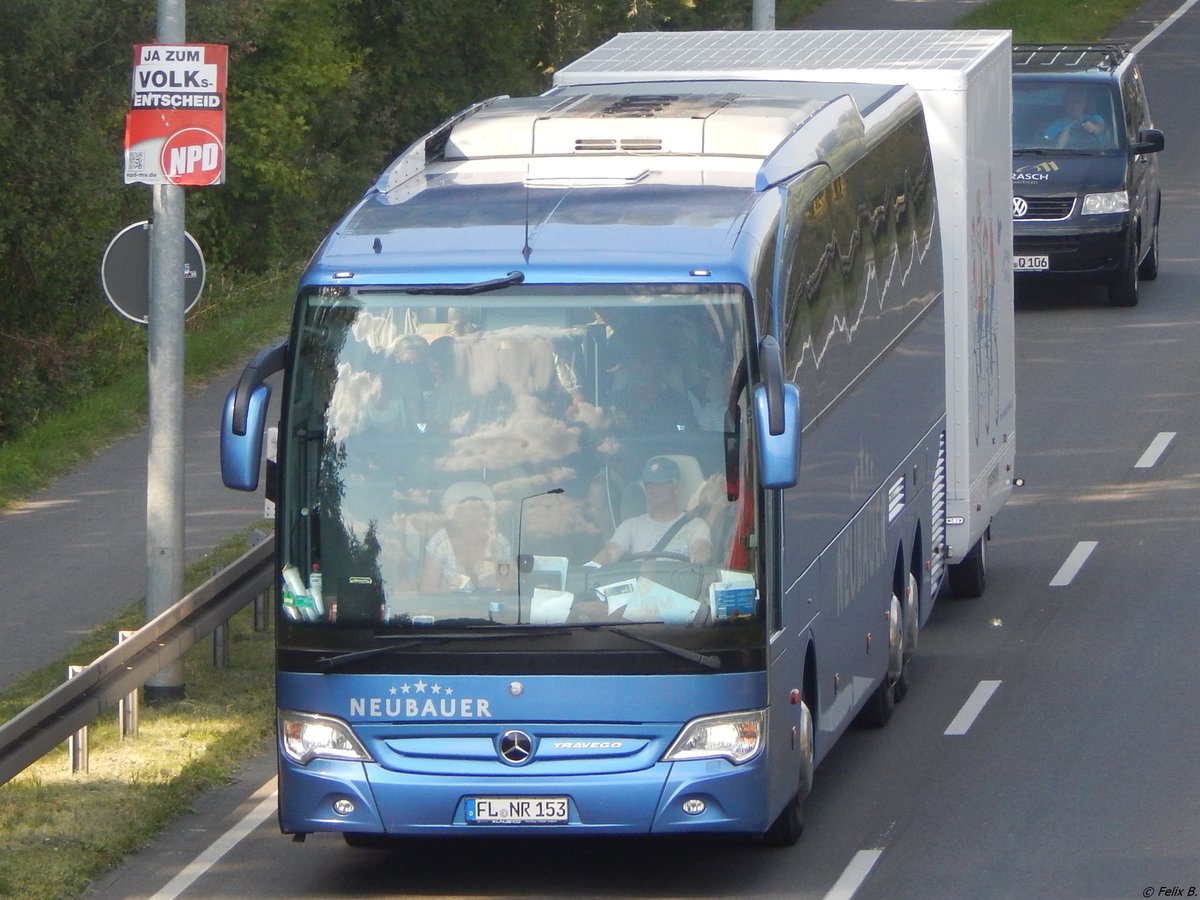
[125,43,229,187]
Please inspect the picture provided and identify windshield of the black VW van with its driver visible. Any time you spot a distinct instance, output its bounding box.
[1013,78,1120,152]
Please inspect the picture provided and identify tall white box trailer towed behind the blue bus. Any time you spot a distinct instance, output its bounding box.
[554,30,1016,596]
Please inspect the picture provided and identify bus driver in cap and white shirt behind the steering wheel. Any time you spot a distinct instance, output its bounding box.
[584,456,713,568]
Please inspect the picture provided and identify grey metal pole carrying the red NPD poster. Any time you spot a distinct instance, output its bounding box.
[145,0,186,704]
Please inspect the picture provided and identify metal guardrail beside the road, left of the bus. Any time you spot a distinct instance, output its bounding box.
[0,536,275,785]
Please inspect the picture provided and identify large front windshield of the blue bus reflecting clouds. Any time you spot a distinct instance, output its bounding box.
[280,283,763,648]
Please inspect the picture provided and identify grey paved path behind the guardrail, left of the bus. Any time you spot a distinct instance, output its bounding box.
[0,374,276,689]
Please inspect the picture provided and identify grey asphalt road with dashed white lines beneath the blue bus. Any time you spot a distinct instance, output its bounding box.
[68,0,1200,899]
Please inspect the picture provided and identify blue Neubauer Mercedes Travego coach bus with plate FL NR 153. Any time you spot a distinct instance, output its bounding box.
[213,33,993,844]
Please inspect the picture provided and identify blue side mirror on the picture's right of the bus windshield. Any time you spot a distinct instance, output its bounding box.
[754,336,800,488]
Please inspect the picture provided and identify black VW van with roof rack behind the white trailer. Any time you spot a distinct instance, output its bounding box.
[1013,44,1164,306]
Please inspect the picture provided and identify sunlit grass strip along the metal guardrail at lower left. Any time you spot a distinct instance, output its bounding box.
[0,526,275,900]
